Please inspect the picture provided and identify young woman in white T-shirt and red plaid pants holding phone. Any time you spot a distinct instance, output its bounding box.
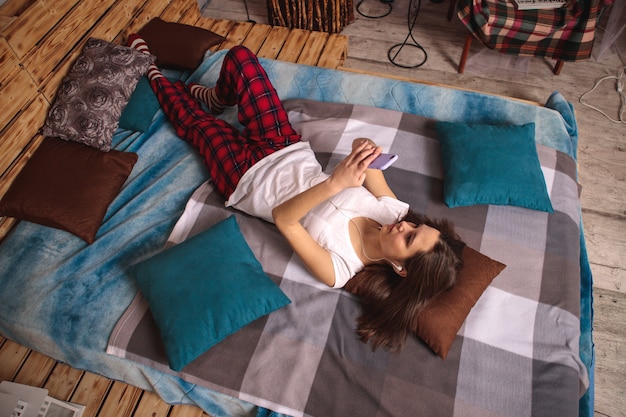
[129,39,462,349]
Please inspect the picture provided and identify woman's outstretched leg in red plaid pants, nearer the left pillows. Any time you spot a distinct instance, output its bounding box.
[129,35,256,197]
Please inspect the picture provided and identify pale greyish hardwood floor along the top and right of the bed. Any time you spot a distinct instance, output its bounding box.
[199,0,626,417]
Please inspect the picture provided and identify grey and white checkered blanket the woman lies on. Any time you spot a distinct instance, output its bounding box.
[109,100,588,417]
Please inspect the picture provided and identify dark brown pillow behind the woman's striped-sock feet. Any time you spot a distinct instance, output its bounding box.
[139,17,226,69]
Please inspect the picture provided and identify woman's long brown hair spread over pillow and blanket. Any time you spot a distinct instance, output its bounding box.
[345,211,465,351]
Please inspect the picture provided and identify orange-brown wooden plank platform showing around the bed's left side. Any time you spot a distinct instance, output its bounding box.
[0,0,348,417]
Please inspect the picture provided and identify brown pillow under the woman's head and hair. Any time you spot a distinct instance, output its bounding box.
[414,246,506,359]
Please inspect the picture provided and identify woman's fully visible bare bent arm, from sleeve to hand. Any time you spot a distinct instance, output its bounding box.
[272,142,380,287]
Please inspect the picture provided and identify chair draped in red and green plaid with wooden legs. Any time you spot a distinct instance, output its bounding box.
[448,0,613,75]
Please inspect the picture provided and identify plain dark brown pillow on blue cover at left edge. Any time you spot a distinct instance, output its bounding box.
[0,138,138,243]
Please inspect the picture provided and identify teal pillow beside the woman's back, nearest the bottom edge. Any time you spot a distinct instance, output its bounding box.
[130,216,291,371]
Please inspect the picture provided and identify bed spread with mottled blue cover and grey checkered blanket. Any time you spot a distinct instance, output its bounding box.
[0,33,593,417]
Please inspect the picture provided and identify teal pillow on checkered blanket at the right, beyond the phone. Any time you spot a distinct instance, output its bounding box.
[436,122,554,213]
